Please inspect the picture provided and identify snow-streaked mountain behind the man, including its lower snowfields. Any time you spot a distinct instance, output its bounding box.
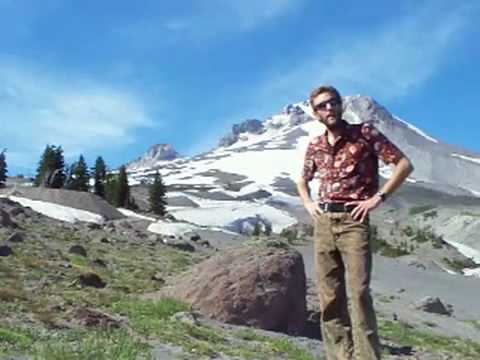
[124,96,480,250]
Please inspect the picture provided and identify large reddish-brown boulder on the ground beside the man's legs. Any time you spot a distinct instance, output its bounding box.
[160,240,307,334]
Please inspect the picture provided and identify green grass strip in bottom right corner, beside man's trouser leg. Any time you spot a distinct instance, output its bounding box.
[379,320,480,360]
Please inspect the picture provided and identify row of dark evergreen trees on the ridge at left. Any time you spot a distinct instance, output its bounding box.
[31,145,166,216]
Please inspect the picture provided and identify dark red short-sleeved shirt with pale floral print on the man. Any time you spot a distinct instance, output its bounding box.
[302,120,404,202]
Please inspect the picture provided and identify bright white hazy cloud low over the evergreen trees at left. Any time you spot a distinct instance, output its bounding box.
[0,58,153,167]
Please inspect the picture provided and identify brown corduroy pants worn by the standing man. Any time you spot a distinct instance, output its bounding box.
[314,213,380,360]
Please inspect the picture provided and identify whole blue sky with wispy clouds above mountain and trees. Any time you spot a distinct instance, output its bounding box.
[0,0,480,174]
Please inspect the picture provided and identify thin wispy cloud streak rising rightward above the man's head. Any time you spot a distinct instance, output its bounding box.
[263,3,473,101]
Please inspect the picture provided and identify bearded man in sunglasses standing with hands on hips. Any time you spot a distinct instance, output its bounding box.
[297,86,413,360]
